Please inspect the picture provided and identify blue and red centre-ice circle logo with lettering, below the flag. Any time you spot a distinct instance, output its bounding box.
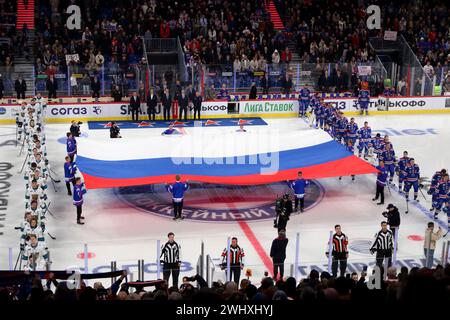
[114,181,324,222]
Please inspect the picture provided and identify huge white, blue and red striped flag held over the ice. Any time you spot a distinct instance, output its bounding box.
[77,130,377,189]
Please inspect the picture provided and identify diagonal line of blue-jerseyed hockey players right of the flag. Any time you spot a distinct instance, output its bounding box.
[300,88,450,219]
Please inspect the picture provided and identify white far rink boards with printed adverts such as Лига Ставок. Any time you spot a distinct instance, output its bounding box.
[0,96,450,124]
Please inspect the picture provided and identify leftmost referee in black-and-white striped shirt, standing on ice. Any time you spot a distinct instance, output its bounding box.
[159,232,181,288]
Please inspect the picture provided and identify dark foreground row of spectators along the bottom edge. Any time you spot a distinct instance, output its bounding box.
[0,265,450,306]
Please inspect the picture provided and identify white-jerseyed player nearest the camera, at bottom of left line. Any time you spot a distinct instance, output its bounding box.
[22,234,50,271]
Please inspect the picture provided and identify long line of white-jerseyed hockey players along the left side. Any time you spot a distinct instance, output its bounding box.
[16,94,51,270]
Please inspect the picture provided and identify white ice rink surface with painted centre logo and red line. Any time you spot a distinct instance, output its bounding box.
[0,115,450,279]
